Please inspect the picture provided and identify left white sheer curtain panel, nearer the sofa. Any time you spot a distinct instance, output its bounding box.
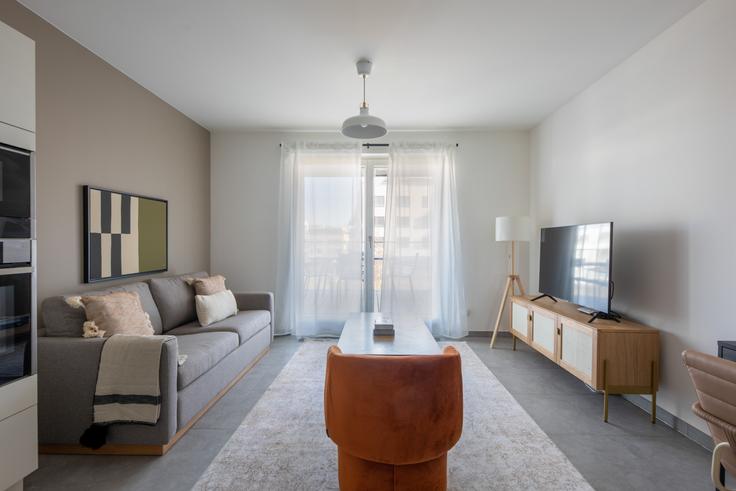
[276,143,362,337]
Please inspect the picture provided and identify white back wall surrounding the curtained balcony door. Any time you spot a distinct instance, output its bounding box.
[210,131,529,331]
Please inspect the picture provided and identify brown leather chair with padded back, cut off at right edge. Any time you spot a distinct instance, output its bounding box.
[682,350,736,490]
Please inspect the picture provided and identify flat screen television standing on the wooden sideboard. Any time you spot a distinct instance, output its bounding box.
[539,222,613,314]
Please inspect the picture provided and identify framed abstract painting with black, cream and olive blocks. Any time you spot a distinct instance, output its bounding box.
[83,186,169,283]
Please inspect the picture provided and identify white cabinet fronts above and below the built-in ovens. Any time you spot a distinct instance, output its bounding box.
[0,18,38,490]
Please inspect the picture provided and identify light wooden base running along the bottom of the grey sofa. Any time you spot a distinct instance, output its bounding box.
[38,347,271,455]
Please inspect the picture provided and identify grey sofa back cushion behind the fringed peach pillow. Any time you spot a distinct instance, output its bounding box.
[41,281,162,337]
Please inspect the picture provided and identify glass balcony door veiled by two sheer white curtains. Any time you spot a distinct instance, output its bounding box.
[276,143,467,337]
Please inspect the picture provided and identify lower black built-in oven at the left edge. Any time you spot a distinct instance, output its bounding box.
[0,267,36,386]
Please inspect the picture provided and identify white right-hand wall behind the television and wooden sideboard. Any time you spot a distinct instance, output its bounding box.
[530,0,736,429]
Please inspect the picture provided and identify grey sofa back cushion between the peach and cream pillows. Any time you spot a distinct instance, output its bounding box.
[148,272,208,332]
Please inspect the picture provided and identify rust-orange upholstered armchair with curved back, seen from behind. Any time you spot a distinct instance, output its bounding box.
[325,346,463,491]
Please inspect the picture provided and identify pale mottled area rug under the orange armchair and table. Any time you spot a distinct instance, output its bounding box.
[194,340,592,491]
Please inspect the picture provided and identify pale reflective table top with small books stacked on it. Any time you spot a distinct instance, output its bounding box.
[337,312,442,355]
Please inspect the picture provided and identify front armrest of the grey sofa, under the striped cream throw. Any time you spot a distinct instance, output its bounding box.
[38,337,179,445]
